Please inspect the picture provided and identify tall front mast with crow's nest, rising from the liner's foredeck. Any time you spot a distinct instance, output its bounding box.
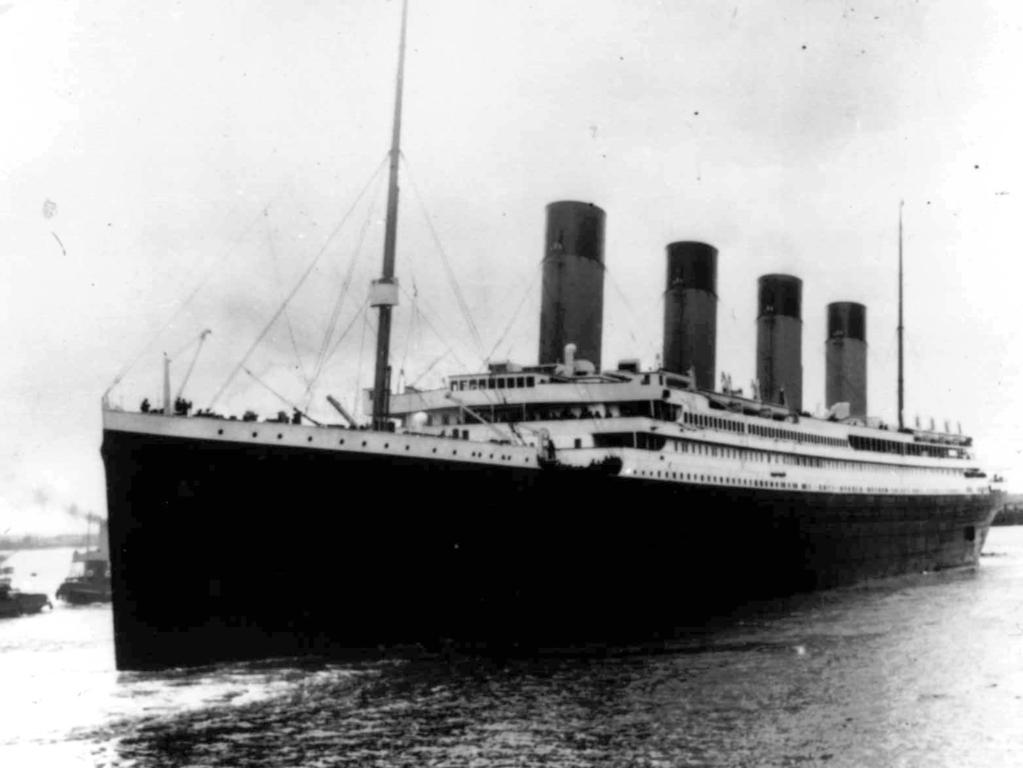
[369,0,408,430]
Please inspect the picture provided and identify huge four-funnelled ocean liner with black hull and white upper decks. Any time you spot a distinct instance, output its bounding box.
[102,3,994,669]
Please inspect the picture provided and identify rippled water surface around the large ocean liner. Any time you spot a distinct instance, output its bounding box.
[0,528,1023,768]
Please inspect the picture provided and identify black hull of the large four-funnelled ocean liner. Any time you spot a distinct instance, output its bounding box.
[103,430,993,669]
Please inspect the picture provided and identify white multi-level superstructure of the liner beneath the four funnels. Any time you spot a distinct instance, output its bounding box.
[382,365,973,466]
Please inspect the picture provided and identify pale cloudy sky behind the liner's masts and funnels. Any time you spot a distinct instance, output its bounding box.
[0,0,1023,533]
